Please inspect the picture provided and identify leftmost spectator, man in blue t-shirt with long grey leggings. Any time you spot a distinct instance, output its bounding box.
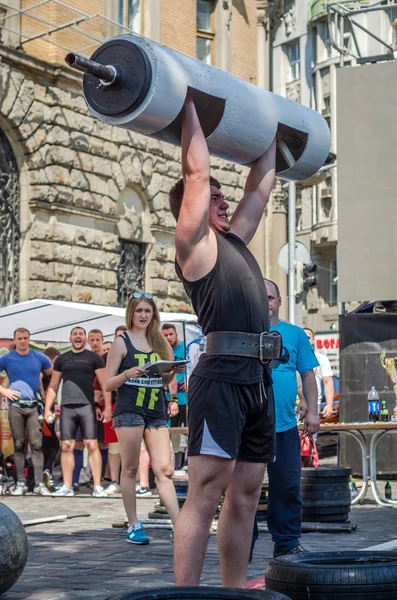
[0,327,52,496]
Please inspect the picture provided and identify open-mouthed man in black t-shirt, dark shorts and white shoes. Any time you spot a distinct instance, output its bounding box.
[44,327,110,497]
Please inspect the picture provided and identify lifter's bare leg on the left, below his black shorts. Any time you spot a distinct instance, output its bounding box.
[174,456,235,586]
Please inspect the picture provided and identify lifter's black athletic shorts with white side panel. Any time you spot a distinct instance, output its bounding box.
[188,375,276,462]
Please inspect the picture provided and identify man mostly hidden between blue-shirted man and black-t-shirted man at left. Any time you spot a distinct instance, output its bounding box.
[41,346,61,492]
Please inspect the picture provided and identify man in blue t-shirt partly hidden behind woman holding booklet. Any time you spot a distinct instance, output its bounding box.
[161,323,187,469]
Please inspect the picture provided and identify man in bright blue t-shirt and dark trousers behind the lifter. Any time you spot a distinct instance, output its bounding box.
[265,279,320,557]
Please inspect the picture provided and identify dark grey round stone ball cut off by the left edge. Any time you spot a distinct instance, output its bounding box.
[0,502,28,596]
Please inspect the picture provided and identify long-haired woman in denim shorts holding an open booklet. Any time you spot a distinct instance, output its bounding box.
[105,292,179,544]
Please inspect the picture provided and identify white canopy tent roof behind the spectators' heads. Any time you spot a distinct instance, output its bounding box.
[0,299,197,344]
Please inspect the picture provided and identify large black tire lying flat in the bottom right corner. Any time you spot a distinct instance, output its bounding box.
[265,551,397,600]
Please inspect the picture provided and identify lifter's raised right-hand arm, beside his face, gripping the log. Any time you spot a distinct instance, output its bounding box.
[230,139,276,244]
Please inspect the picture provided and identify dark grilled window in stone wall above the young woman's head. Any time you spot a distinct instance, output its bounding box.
[117,241,146,306]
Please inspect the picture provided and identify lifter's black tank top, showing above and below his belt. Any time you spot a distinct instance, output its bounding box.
[176,233,271,383]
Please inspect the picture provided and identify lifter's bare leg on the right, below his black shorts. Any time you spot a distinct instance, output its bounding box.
[218,461,266,588]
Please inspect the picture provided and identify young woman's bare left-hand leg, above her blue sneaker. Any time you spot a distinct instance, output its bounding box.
[116,427,143,525]
